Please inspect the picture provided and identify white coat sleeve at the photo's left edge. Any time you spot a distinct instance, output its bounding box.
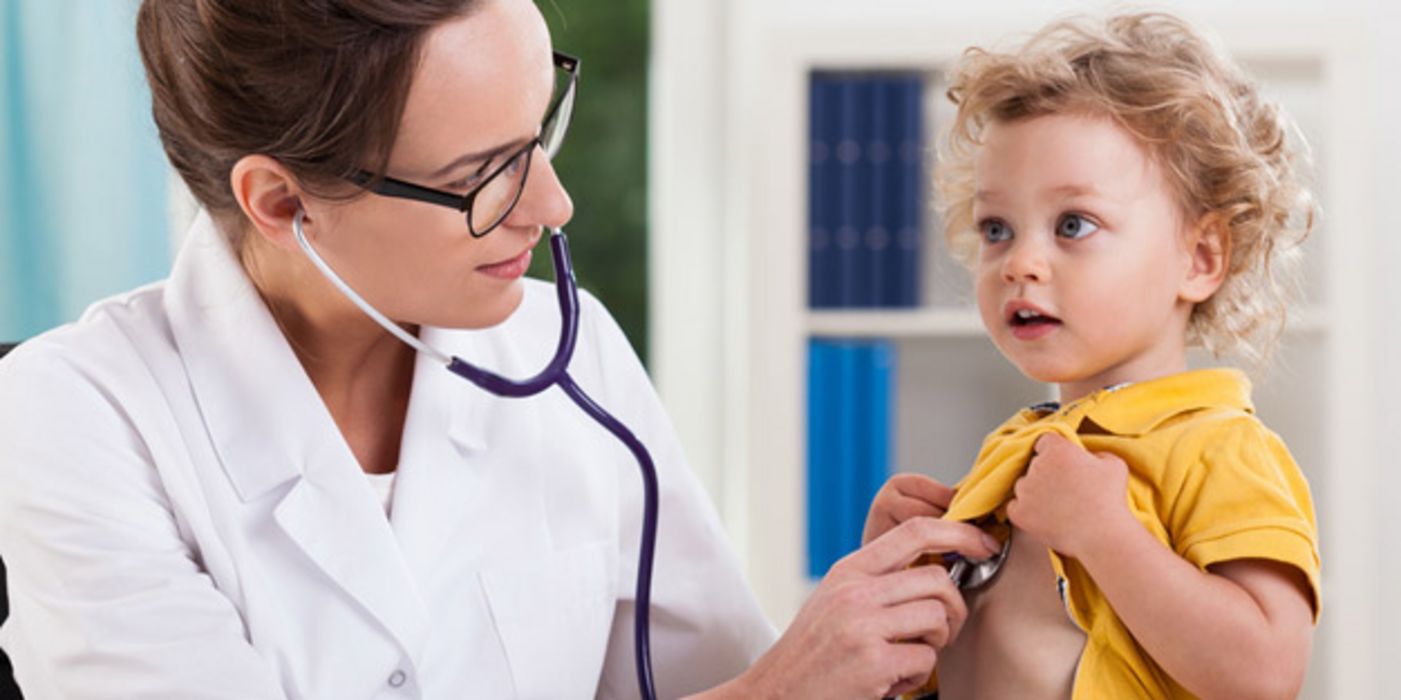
[0,337,284,700]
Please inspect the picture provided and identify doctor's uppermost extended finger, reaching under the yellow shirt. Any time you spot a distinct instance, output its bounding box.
[836,518,1000,575]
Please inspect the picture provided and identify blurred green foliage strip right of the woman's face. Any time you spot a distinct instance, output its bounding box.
[531,0,650,360]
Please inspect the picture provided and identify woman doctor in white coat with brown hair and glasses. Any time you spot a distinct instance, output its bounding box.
[0,0,992,700]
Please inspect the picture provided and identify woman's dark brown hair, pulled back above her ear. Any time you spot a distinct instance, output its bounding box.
[136,0,478,235]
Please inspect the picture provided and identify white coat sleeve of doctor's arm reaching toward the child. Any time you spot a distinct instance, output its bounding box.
[563,295,776,699]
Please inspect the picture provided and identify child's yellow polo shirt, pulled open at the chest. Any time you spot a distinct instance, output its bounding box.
[926,370,1320,700]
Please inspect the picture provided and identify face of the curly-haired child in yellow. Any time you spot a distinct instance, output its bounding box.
[974,115,1192,400]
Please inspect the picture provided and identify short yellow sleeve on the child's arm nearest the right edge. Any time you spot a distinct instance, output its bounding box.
[1167,416,1321,620]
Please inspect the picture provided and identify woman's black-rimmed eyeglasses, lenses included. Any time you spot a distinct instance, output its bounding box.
[349,52,580,238]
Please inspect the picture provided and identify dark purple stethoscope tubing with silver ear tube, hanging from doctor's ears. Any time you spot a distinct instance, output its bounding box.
[291,209,657,700]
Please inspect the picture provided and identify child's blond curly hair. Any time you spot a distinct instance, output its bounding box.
[934,13,1316,363]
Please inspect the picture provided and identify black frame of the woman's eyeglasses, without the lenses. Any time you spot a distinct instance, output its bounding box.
[347,50,580,238]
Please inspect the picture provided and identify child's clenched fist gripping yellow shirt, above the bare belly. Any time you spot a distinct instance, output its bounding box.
[1007,433,1133,557]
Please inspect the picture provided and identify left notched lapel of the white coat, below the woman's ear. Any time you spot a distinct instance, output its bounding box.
[165,213,427,658]
